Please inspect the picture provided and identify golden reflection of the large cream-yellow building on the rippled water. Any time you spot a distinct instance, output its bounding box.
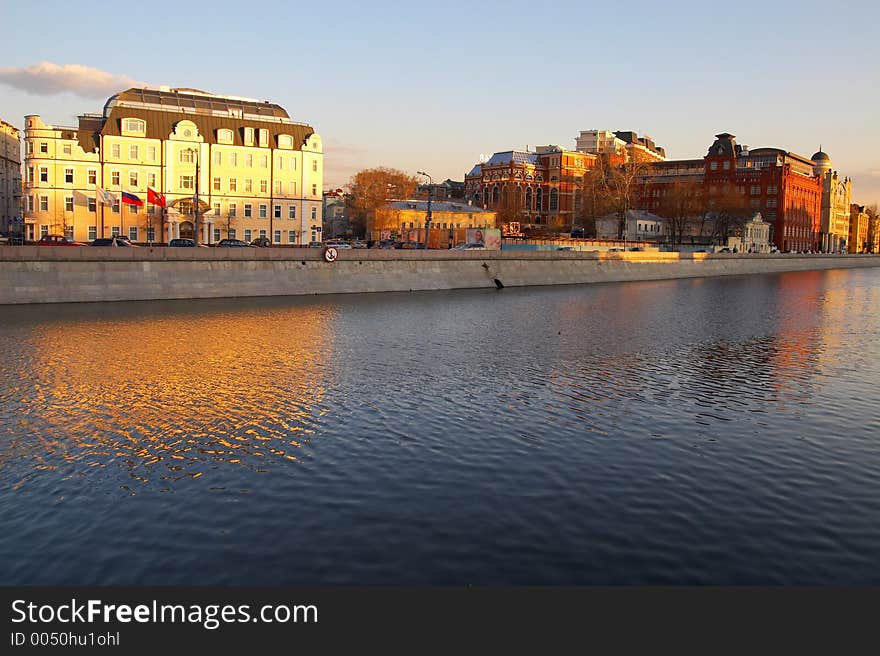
[15,306,329,491]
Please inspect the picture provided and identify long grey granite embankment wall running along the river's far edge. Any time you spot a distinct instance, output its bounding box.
[0,246,880,305]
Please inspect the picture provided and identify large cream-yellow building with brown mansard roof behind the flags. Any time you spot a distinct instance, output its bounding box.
[25,87,324,244]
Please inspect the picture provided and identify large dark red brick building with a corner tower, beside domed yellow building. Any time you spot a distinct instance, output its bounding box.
[641,132,822,251]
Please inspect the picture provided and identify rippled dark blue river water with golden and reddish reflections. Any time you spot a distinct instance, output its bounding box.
[0,269,880,585]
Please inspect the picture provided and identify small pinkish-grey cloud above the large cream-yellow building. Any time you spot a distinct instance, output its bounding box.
[0,62,145,98]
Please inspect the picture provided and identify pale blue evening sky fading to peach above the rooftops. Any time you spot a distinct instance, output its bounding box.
[0,0,880,204]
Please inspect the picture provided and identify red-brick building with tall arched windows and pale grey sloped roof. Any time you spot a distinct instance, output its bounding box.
[465,146,597,234]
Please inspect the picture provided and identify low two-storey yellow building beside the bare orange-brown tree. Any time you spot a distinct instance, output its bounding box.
[367,200,497,239]
